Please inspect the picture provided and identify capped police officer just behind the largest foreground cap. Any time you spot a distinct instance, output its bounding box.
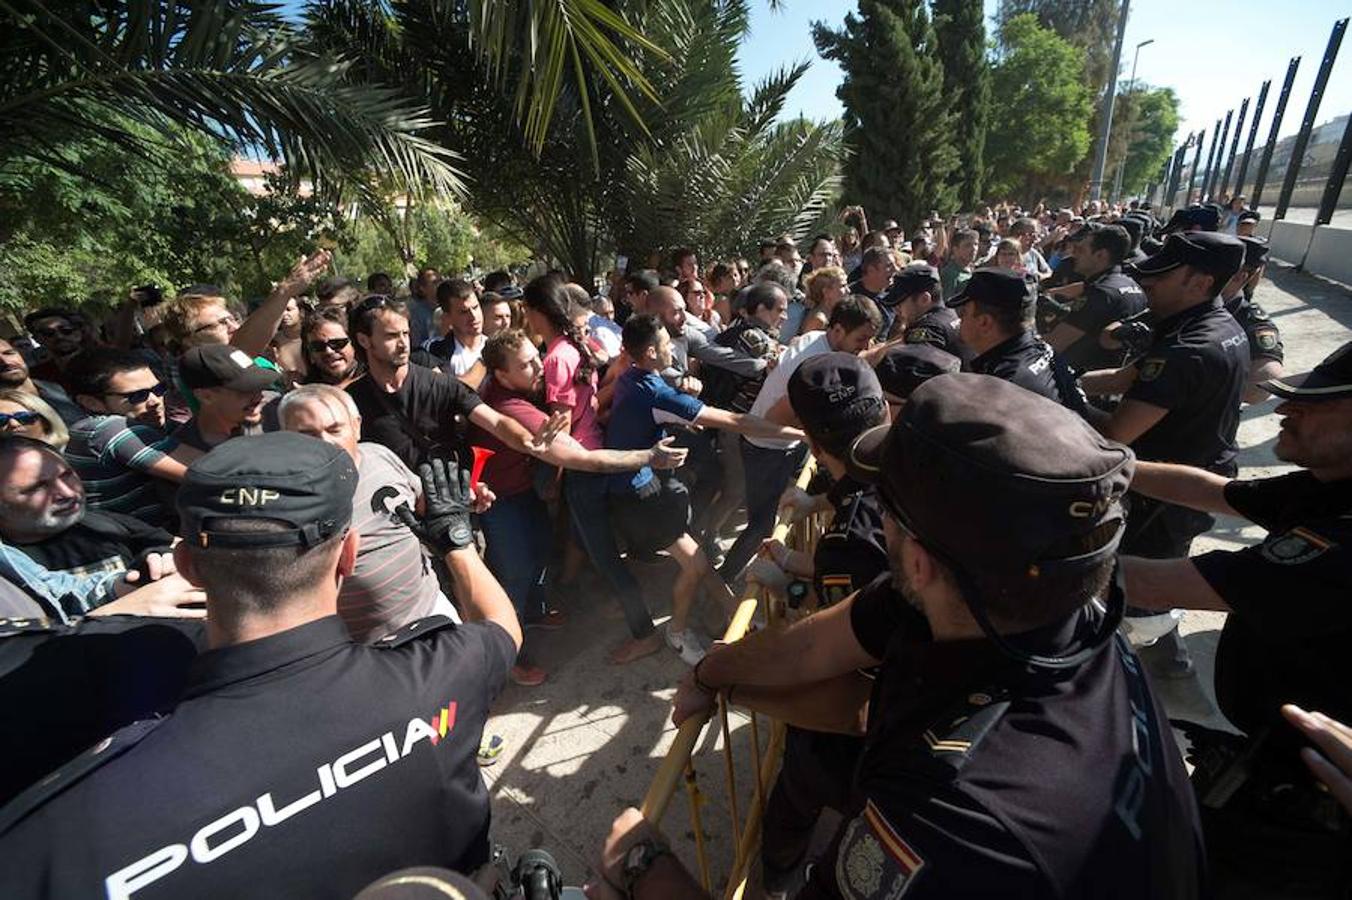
[948,269,1080,407]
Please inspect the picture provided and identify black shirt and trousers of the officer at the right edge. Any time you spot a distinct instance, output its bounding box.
[1192,472,1352,897]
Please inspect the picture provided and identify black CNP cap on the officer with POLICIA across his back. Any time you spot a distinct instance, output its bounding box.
[177,431,357,547]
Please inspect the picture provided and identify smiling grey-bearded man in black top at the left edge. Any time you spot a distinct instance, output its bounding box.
[0,436,173,589]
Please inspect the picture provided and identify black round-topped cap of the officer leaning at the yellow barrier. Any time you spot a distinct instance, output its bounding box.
[788,351,887,442]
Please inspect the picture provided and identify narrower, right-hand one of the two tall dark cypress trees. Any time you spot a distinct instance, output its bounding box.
[934,0,991,209]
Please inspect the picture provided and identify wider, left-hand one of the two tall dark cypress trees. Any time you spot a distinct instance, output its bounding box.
[813,0,959,227]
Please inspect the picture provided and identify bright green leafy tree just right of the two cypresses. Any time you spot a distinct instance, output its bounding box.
[987,15,1091,196]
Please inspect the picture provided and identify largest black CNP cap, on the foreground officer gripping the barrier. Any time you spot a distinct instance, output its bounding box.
[850,373,1136,577]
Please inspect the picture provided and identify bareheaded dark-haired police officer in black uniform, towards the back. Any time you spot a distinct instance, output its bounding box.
[1045,226,1145,372]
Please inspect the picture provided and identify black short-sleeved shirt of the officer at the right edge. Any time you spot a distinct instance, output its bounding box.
[1192,470,1352,751]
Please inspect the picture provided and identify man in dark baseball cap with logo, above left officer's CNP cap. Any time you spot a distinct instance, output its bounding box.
[173,343,277,453]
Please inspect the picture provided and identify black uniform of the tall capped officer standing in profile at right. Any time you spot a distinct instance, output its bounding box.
[1122,297,1249,559]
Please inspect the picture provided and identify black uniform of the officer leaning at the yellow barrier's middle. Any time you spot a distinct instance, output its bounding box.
[761,474,888,889]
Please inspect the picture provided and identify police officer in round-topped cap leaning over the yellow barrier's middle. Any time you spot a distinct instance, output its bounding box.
[746,353,887,892]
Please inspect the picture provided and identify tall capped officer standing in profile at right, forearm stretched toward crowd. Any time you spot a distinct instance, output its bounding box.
[1080,231,1249,664]
